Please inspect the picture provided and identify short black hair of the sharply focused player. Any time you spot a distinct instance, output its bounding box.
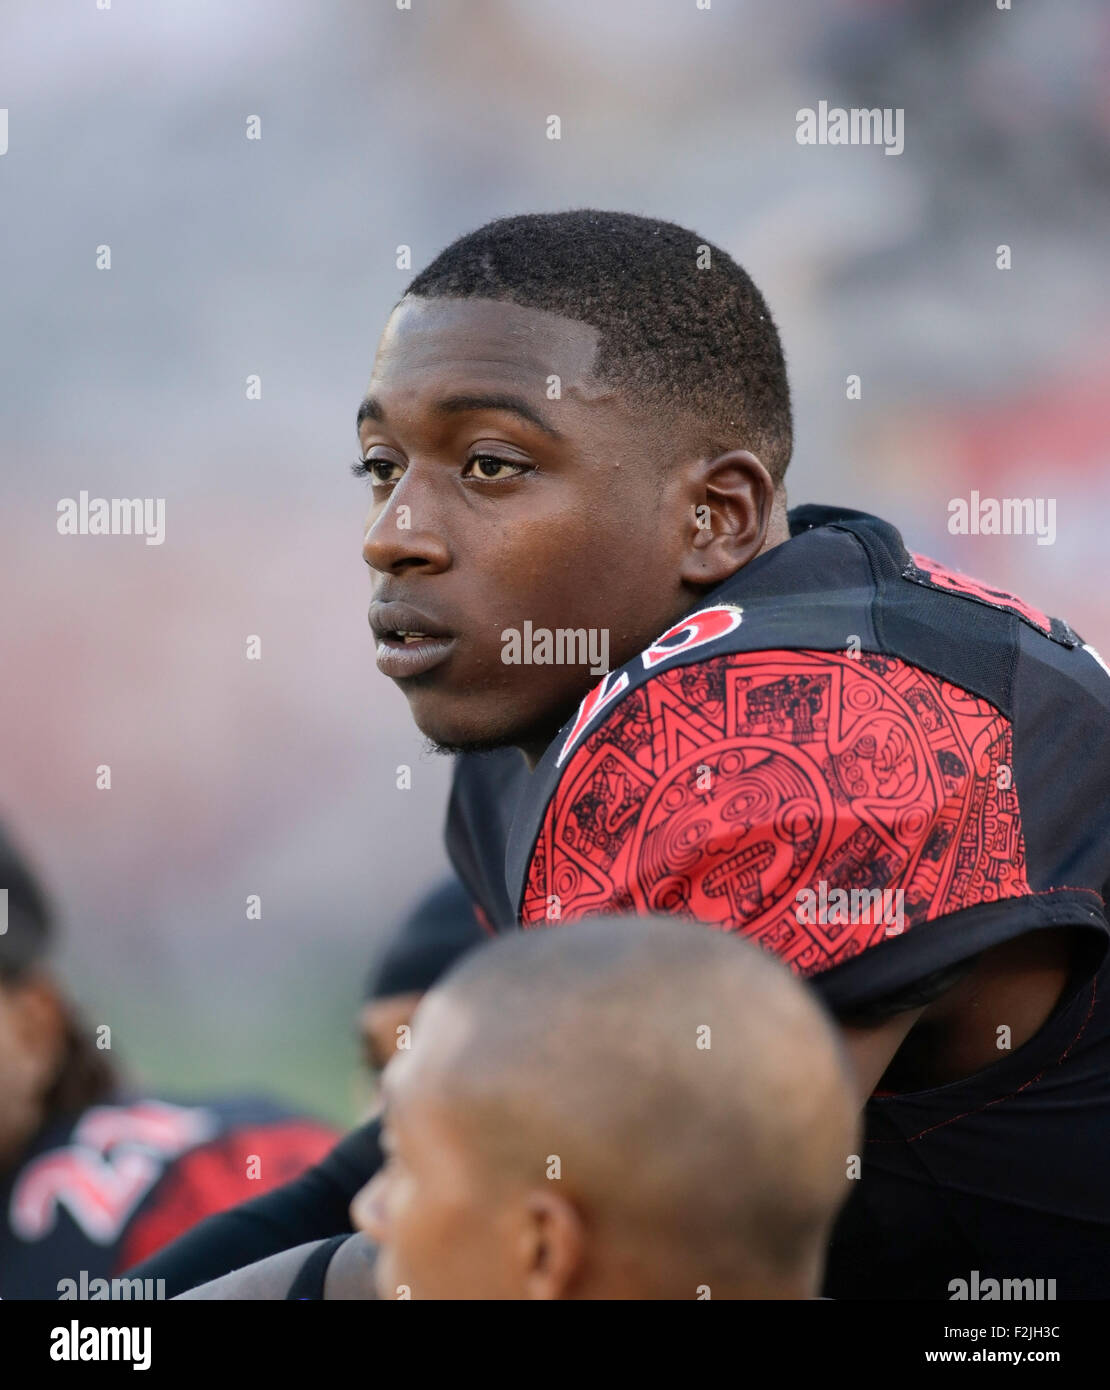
[406,209,793,482]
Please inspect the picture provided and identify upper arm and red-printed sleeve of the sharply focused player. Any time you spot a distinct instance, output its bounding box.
[525,644,1106,1098]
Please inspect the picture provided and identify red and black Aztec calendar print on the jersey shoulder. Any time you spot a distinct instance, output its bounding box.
[521,651,1031,974]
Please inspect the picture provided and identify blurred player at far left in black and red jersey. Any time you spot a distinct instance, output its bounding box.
[0,831,335,1300]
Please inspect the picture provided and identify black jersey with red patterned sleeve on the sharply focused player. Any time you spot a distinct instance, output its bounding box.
[447,506,1110,1298]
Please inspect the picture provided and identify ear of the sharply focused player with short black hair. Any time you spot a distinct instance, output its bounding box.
[681,449,775,588]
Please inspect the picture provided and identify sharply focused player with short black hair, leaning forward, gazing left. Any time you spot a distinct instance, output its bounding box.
[132,211,1110,1298]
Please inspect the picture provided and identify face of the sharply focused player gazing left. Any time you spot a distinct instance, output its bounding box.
[358,299,692,755]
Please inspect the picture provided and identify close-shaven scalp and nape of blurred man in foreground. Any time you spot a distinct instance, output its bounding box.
[361,917,857,1297]
